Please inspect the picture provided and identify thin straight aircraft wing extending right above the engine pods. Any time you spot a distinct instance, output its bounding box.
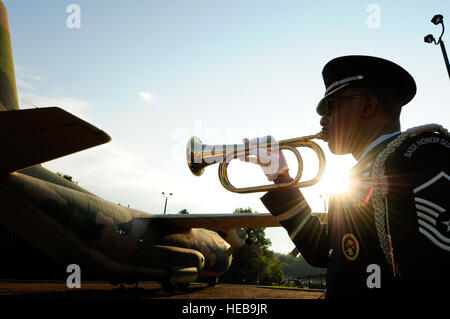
[141,214,281,231]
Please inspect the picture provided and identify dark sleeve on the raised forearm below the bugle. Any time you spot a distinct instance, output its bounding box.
[261,189,329,268]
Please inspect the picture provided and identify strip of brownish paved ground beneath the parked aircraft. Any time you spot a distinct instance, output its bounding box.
[0,282,323,299]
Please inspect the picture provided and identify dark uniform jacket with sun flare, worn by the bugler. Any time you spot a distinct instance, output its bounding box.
[261,133,450,298]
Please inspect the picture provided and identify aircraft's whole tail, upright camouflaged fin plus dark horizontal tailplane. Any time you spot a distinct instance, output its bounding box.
[0,0,111,173]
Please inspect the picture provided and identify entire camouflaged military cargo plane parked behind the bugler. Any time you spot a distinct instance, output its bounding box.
[0,1,279,287]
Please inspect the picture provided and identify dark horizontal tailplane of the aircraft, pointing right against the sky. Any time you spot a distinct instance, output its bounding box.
[0,107,111,173]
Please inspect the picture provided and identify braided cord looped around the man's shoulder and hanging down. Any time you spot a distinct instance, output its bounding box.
[372,124,449,277]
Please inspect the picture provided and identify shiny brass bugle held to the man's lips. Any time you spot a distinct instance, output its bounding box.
[186,132,326,193]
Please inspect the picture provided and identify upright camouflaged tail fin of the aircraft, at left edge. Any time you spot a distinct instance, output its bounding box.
[0,1,19,111]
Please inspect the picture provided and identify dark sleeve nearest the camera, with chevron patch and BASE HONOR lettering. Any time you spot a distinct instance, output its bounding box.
[386,133,450,278]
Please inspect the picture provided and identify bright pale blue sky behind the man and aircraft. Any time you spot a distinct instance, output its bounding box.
[4,0,450,253]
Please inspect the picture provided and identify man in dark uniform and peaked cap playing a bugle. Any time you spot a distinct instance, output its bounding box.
[253,56,450,298]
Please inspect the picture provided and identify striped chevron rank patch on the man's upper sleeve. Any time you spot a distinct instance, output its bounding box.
[414,172,450,251]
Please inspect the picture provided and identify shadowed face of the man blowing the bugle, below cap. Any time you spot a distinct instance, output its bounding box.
[320,88,367,155]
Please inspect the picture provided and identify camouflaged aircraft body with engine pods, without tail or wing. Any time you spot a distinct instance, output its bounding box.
[0,166,231,283]
